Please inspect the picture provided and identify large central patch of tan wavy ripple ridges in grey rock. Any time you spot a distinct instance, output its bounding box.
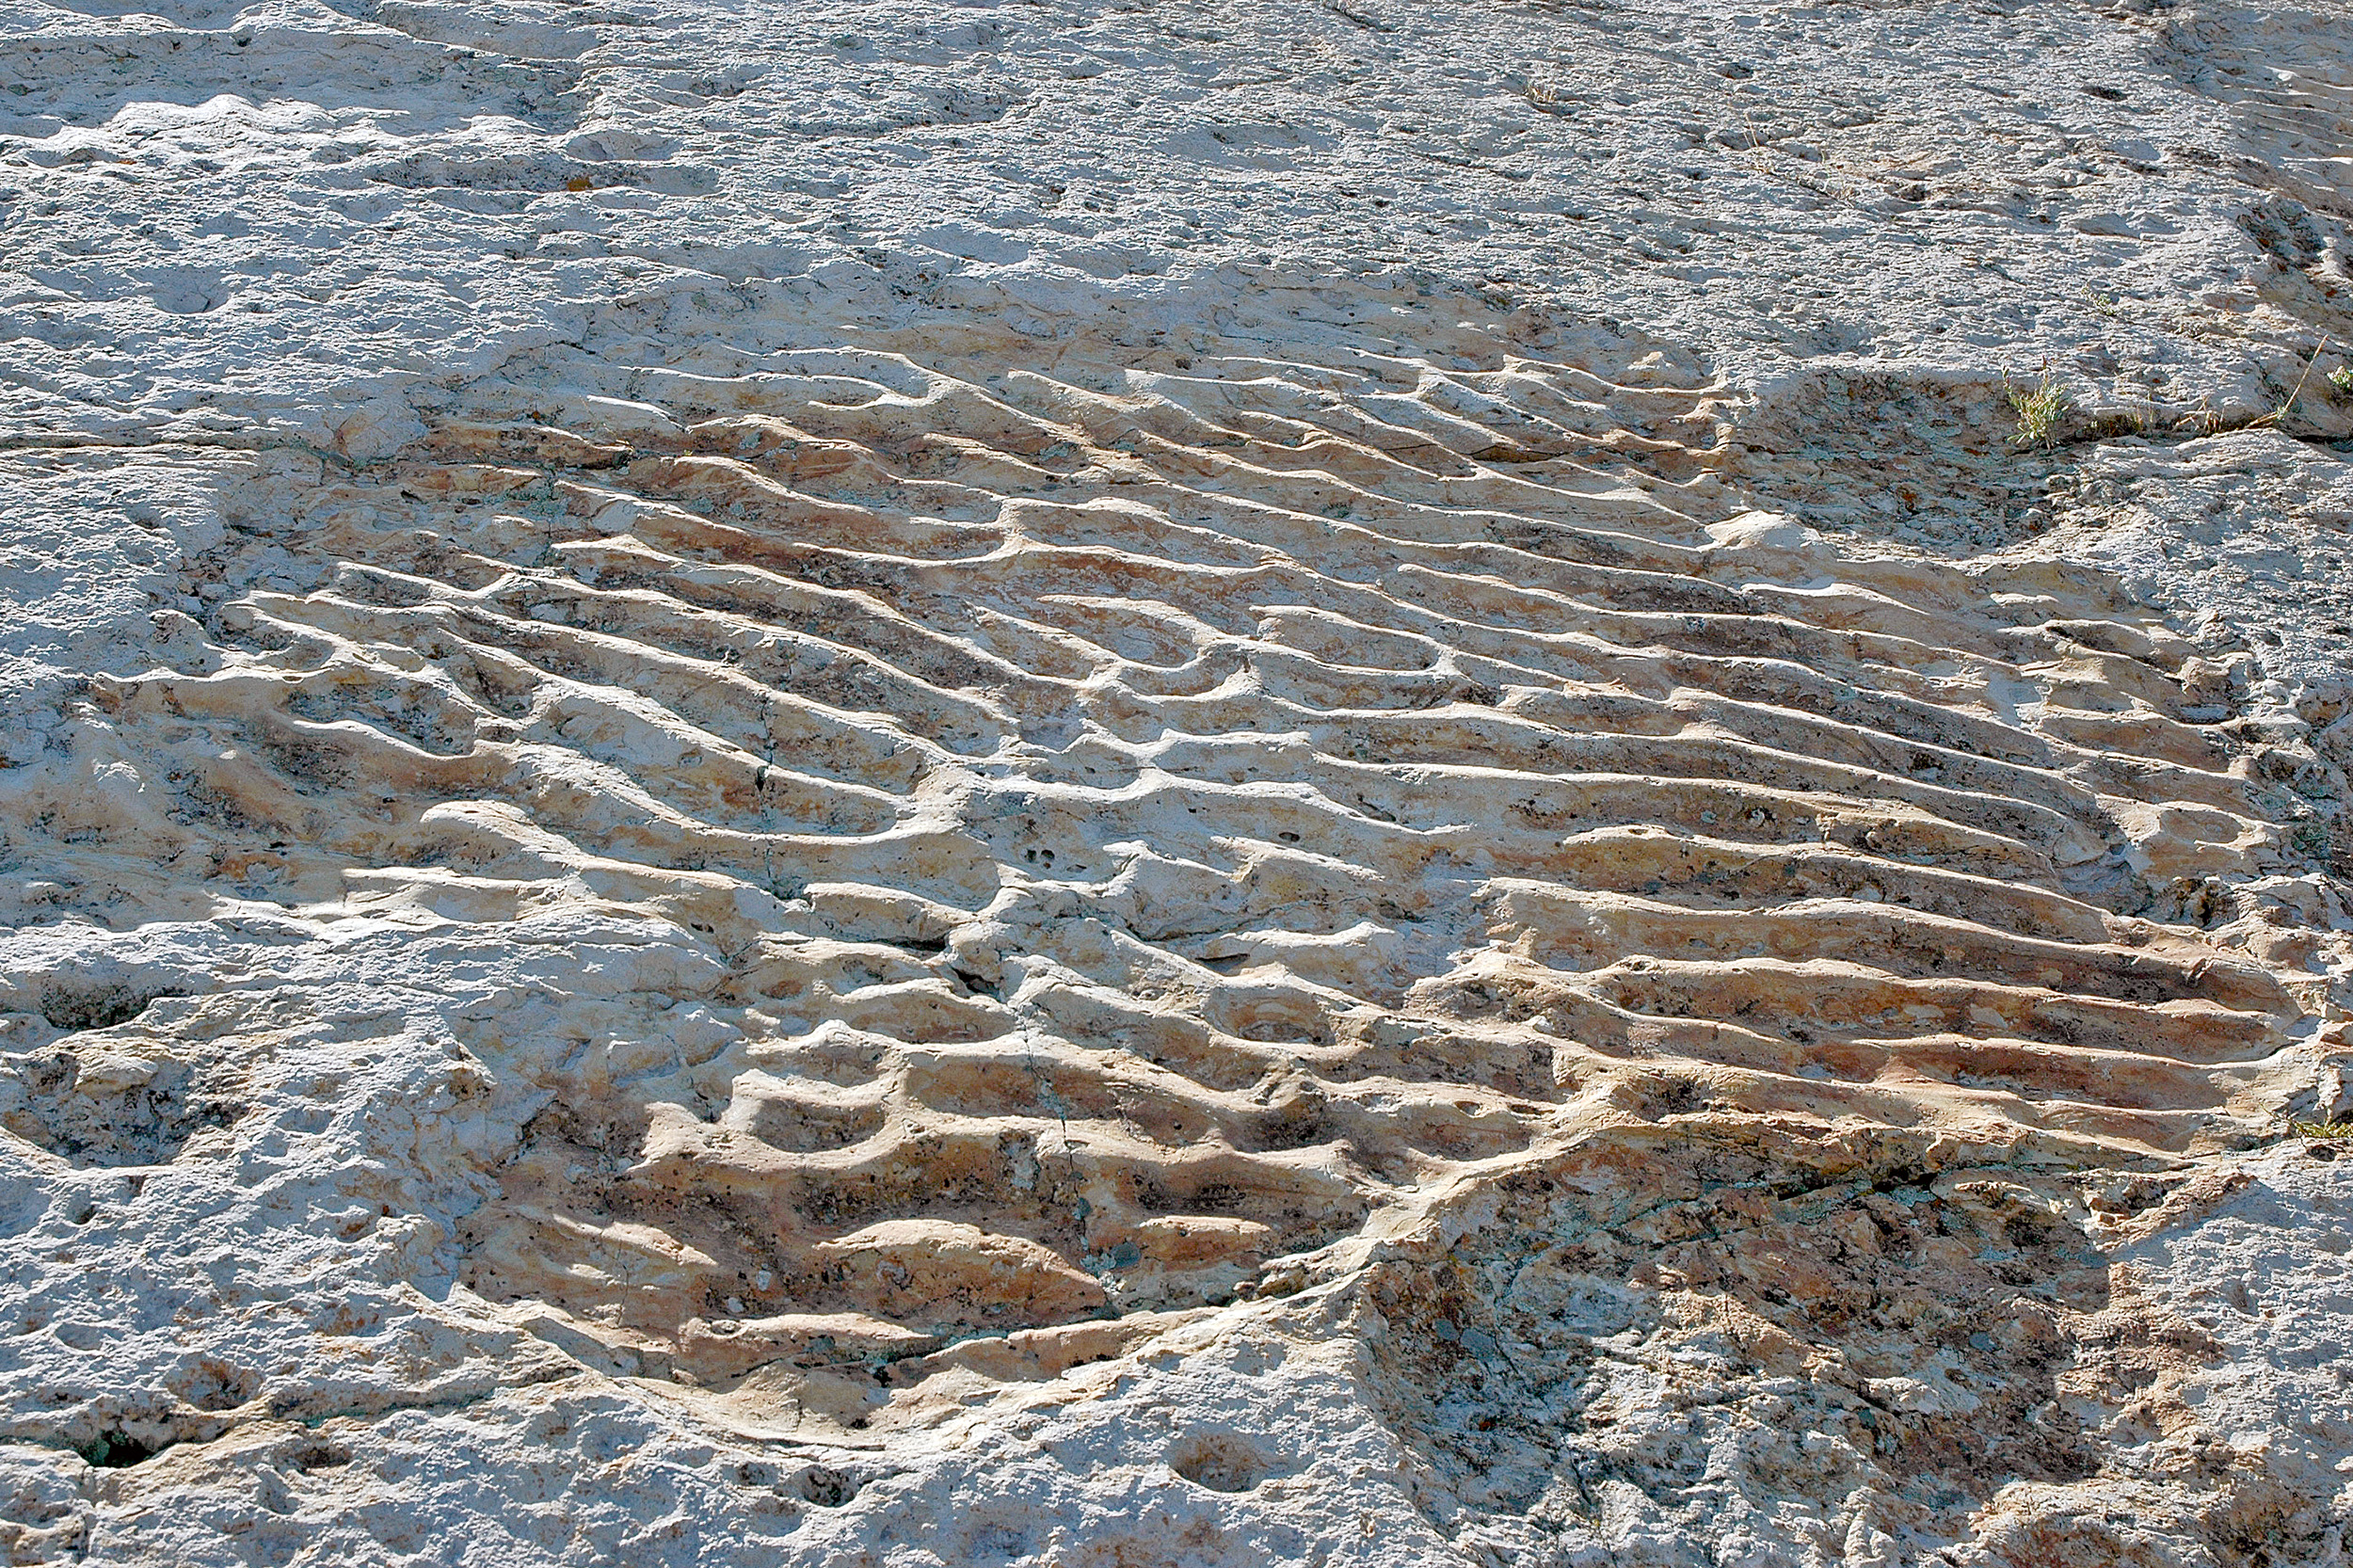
[5,323,2311,1469]
